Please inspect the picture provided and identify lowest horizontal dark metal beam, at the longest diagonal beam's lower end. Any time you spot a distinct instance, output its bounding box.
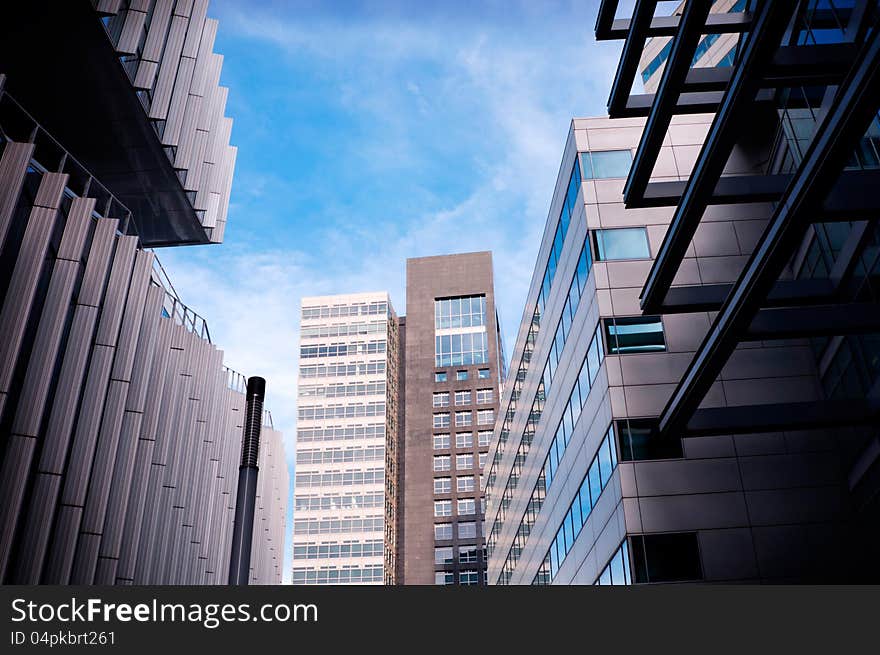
[681,399,880,437]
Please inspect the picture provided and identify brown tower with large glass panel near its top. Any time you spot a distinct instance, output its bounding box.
[398,252,504,585]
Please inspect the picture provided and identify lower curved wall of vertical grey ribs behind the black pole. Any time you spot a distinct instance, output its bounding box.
[0,142,288,584]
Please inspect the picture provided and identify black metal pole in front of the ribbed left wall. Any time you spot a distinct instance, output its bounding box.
[229,377,266,585]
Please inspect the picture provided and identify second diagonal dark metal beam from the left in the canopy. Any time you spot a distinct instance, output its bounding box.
[623,2,710,204]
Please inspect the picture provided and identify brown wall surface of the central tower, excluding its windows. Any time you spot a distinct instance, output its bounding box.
[400,252,501,585]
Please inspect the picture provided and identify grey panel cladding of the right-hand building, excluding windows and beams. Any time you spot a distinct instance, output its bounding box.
[487,116,848,584]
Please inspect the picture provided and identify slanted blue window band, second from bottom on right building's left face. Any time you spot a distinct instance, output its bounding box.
[532,426,617,580]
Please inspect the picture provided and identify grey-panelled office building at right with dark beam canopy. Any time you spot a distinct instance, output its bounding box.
[487,0,880,584]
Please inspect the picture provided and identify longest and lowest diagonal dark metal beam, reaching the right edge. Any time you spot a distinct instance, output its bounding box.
[659,21,880,434]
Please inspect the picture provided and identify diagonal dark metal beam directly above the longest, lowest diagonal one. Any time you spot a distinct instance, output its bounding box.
[642,0,796,313]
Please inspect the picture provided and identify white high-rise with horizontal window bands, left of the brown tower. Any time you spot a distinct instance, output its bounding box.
[293,292,400,584]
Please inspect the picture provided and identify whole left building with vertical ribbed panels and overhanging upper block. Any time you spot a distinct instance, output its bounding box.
[0,0,287,584]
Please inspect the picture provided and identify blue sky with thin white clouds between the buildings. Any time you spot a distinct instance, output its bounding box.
[158,0,620,584]
